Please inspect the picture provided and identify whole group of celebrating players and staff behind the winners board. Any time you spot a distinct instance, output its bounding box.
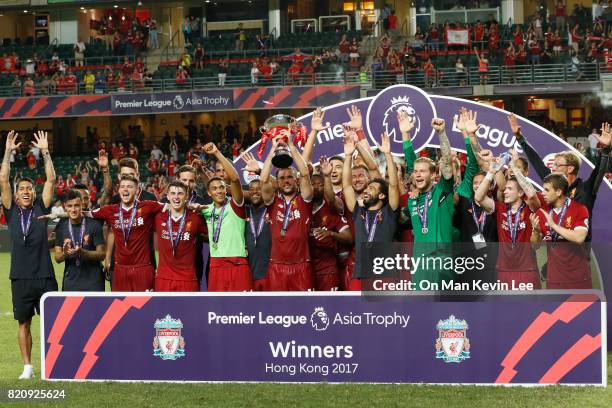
[0,107,612,378]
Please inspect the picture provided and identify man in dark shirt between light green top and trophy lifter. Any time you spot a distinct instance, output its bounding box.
[245,179,272,292]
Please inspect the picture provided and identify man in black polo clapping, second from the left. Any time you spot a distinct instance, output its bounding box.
[55,190,106,292]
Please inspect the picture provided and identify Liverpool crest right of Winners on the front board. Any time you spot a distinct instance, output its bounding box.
[436,315,470,363]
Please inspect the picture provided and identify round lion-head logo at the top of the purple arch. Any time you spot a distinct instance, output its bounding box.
[366,85,437,154]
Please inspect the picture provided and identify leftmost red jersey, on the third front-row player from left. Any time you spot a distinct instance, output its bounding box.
[91,201,164,266]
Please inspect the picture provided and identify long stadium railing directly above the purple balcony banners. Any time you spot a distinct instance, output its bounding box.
[0,63,612,97]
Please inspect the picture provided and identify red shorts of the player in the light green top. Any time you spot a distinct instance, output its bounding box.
[208,257,253,292]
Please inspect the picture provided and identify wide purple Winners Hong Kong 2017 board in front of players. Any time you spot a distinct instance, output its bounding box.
[41,291,606,385]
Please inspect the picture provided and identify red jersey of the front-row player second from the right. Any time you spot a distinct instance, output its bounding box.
[495,201,538,272]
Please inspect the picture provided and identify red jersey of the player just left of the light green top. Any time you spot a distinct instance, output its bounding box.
[155,210,207,281]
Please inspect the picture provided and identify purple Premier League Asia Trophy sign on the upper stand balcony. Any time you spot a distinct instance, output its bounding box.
[111,89,234,115]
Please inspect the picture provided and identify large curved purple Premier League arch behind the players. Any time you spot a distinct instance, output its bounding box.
[238,85,612,344]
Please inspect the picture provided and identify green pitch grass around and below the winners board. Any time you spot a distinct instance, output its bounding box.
[0,253,612,408]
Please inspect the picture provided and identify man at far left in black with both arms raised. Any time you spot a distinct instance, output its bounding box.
[0,131,57,379]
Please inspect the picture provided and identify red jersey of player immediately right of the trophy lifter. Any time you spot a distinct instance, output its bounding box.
[310,201,349,273]
